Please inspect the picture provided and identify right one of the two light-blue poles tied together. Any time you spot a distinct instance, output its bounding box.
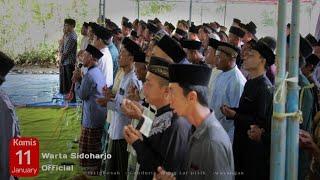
[286,0,300,180]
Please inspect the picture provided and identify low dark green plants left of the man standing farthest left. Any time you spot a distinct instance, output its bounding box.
[16,44,57,65]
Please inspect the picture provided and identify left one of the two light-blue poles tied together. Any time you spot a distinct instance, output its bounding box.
[270,0,288,180]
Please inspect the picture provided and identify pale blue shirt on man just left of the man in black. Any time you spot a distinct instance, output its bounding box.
[209,66,247,142]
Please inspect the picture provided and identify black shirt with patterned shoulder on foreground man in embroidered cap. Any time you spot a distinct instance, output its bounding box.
[132,105,191,180]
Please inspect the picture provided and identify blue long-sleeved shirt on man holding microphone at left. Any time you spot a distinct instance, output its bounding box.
[75,66,107,128]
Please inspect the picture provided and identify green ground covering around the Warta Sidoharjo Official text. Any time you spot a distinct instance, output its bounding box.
[17,108,105,180]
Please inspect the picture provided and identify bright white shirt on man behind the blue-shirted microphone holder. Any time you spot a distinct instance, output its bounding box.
[98,46,113,87]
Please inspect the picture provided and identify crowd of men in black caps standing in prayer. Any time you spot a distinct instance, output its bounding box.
[0,17,320,180]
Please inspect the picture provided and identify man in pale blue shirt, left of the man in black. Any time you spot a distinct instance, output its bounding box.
[209,42,246,142]
